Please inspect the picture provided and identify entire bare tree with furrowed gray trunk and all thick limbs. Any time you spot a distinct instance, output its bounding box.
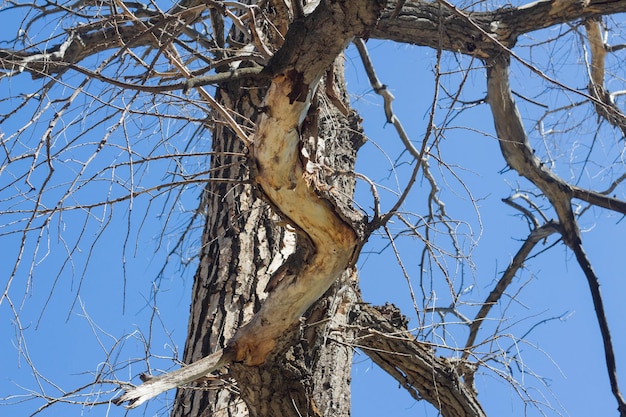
[0,0,626,417]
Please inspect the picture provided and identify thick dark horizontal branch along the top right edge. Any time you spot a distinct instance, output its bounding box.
[370,0,626,58]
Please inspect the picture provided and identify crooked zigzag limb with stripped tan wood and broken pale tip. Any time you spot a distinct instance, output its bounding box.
[117,0,382,407]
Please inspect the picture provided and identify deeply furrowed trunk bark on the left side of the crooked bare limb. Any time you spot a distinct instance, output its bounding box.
[171,76,272,417]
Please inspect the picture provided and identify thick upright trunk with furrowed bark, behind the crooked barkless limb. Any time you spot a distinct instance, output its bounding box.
[172,56,363,417]
